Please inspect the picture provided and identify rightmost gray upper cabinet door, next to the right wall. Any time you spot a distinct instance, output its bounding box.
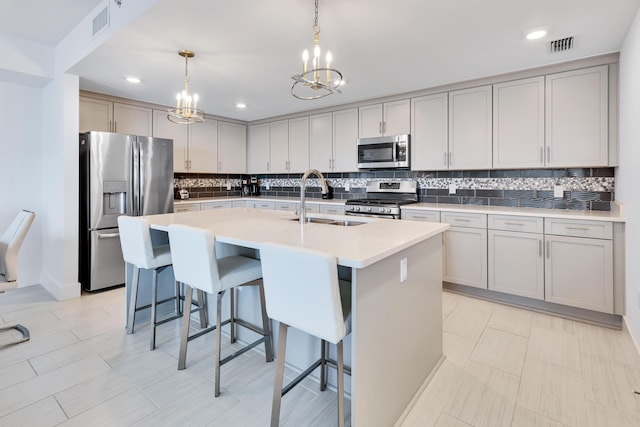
[546,65,609,167]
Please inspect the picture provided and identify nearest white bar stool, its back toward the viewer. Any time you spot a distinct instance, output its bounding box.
[260,243,351,427]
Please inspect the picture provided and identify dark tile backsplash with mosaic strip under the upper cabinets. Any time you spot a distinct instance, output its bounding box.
[174,168,615,211]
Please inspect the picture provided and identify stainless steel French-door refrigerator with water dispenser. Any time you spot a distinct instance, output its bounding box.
[78,132,174,291]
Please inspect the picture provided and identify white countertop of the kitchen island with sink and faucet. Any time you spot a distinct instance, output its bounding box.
[146,208,449,268]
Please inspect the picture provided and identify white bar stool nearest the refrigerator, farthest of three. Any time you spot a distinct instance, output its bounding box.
[118,215,207,350]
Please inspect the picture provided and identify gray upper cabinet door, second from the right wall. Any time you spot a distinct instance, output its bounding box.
[493,77,545,168]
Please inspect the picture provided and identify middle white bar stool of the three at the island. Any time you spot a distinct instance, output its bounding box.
[169,224,273,397]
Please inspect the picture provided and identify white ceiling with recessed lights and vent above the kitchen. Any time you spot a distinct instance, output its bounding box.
[0,0,640,121]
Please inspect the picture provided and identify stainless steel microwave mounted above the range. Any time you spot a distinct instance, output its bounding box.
[358,135,411,169]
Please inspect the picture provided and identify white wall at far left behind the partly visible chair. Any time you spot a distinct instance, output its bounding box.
[0,82,43,287]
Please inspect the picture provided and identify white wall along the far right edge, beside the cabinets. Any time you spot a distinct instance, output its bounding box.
[616,7,640,343]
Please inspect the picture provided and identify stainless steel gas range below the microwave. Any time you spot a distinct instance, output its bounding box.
[345,181,418,219]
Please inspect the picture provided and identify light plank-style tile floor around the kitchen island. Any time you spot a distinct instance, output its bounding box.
[0,286,640,427]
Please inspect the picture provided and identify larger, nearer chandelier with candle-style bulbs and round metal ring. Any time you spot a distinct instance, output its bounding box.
[291,0,343,99]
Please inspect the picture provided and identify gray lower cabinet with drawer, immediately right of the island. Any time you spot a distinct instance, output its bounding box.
[440,211,488,289]
